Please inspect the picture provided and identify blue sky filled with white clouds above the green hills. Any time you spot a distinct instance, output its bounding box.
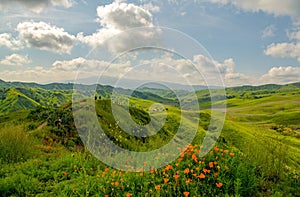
[0,0,300,86]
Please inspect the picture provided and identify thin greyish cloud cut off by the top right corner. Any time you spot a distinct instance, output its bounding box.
[208,0,300,22]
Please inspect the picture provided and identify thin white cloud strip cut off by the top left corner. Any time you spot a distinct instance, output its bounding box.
[0,0,74,13]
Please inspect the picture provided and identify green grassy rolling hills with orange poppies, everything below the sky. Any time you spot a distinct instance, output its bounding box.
[0,81,300,197]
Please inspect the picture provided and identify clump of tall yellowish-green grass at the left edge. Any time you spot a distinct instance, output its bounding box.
[0,126,35,163]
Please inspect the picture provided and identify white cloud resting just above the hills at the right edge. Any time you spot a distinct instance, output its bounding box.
[259,66,300,84]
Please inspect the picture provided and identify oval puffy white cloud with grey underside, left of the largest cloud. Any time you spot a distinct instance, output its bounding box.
[17,21,76,54]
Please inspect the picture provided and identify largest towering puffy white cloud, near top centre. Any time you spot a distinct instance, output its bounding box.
[77,1,158,52]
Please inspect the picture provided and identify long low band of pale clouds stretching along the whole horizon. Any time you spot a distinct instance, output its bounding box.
[0,55,300,86]
